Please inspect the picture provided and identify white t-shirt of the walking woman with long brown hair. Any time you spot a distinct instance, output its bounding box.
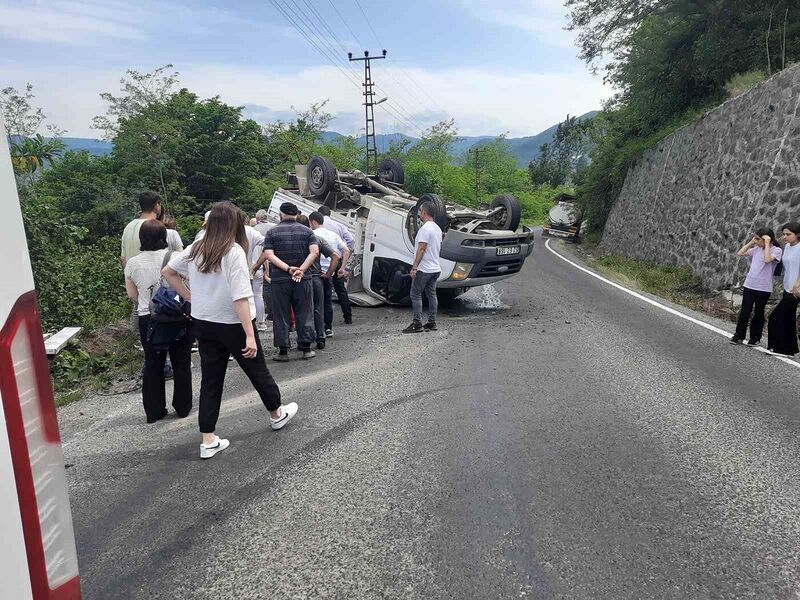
[169,244,256,324]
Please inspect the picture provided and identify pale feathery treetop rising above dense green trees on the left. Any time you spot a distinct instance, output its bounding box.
[92,64,180,140]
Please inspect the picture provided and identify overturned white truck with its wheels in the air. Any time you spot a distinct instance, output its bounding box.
[268,157,533,306]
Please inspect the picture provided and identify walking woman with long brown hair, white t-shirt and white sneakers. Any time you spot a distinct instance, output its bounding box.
[163,202,297,458]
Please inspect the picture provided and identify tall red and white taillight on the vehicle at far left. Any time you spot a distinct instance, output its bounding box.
[0,292,81,600]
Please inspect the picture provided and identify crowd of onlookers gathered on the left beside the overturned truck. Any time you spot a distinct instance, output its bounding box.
[121,191,442,459]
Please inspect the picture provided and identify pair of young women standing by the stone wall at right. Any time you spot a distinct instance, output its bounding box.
[730,221,800,356]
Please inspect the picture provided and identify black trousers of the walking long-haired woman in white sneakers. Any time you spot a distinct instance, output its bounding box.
[195,320,281,433]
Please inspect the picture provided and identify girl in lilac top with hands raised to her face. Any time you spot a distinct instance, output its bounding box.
[730,227,783,346]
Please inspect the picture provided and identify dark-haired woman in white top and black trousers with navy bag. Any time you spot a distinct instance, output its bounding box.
[125,219,192,423]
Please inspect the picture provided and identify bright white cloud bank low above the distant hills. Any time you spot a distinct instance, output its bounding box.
[0,62,611,137]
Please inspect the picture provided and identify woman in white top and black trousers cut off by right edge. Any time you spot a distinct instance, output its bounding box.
[767,221,800,356]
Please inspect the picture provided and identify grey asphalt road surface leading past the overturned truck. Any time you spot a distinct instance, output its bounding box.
[60,236,800,600]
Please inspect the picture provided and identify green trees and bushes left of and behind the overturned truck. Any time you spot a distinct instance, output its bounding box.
[0,72,571,330]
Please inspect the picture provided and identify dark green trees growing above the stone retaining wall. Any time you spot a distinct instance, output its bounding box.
[566,0,800,231]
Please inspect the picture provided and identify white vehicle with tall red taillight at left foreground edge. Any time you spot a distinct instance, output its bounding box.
[0,122,81,600]
